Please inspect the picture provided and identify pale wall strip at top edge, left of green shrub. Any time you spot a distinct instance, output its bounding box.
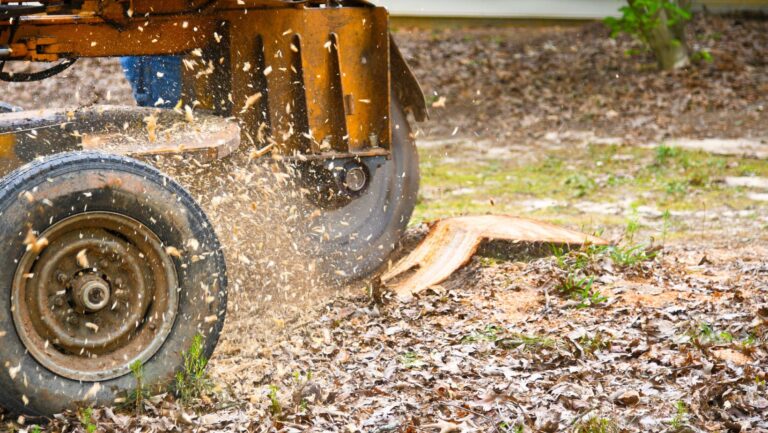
[373,0,624,19]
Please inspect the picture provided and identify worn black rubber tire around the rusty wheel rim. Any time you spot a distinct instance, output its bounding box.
[0,152,227,416]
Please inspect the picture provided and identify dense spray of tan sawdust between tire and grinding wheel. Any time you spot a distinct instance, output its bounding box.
[159,148,356,350]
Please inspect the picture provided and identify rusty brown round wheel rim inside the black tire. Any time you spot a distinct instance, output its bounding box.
[12,212,178,381]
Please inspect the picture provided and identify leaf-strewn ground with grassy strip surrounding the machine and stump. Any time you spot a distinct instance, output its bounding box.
[0,13,768,433]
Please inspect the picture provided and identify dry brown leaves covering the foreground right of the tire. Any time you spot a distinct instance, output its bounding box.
[24,241,768,433]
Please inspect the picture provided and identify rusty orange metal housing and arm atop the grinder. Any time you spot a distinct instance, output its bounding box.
[0,0,396,156]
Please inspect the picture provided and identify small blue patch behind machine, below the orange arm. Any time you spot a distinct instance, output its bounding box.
[120,56,181,108]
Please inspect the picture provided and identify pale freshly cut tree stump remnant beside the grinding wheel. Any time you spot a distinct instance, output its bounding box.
[381,215,608,298]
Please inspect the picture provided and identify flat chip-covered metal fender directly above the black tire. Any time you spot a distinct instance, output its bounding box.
[0,105,240,173]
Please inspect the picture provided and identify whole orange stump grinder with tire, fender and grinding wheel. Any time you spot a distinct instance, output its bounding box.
[0,0,427,416]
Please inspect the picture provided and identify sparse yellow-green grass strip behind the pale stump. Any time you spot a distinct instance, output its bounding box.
[412,145,768,239]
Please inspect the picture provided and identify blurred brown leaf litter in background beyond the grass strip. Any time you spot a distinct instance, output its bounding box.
[395,15,768,143]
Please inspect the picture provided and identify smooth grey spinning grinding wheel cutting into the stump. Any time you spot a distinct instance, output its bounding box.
[315,99,419,283]
